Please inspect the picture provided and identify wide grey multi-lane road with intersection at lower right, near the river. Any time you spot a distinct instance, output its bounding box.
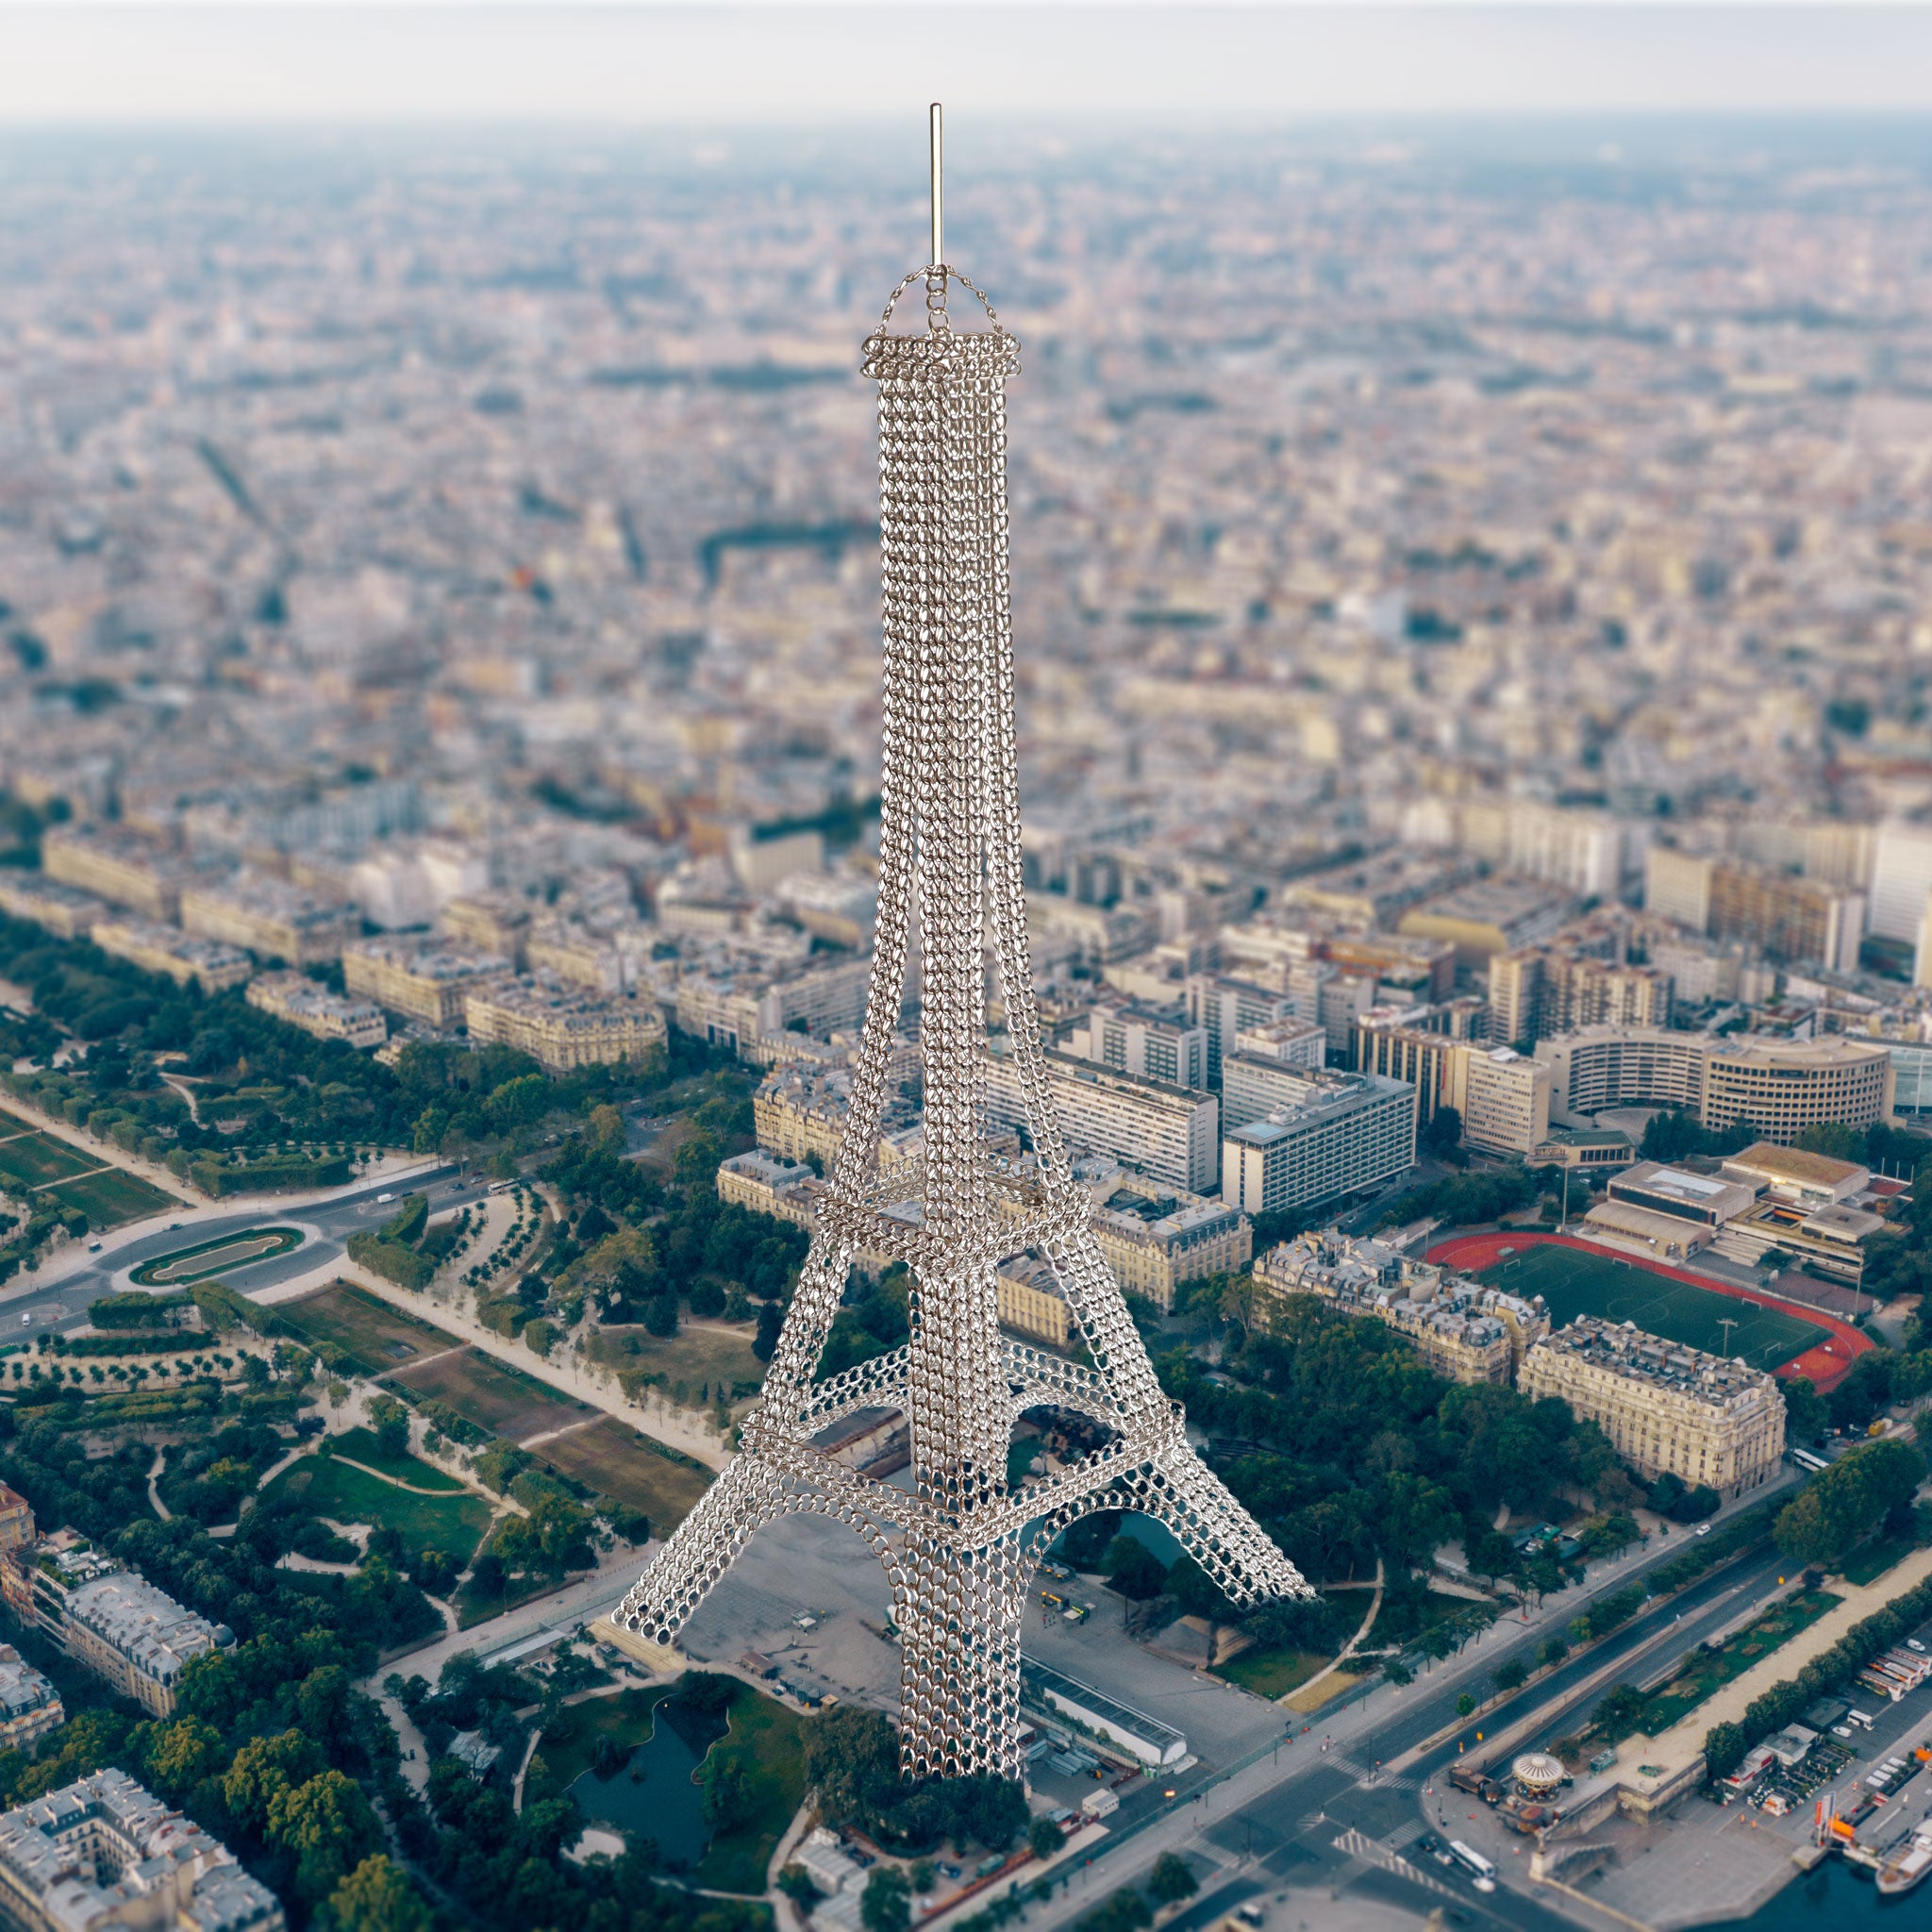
[1030,1541,1787,1932]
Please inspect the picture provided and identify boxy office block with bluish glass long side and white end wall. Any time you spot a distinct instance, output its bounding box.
[1221,1074,1416,1215]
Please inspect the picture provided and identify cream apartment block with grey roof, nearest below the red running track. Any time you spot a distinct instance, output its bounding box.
[1517,1316,1785,1497]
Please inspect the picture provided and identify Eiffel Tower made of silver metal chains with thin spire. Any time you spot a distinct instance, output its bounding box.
[616,108,1307,1777]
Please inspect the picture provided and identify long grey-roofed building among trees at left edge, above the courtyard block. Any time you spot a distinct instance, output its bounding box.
[0,1532,234,1718]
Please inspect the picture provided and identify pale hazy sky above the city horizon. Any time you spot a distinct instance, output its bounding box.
[11,0,1932,125]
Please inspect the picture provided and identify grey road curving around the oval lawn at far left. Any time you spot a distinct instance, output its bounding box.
[0,1167,475,1335]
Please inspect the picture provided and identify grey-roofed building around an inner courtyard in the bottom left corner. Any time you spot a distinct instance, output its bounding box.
[0,1770,288,1932]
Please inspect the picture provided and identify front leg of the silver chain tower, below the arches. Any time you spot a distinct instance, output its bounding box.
[898,1534,1025,1777]
